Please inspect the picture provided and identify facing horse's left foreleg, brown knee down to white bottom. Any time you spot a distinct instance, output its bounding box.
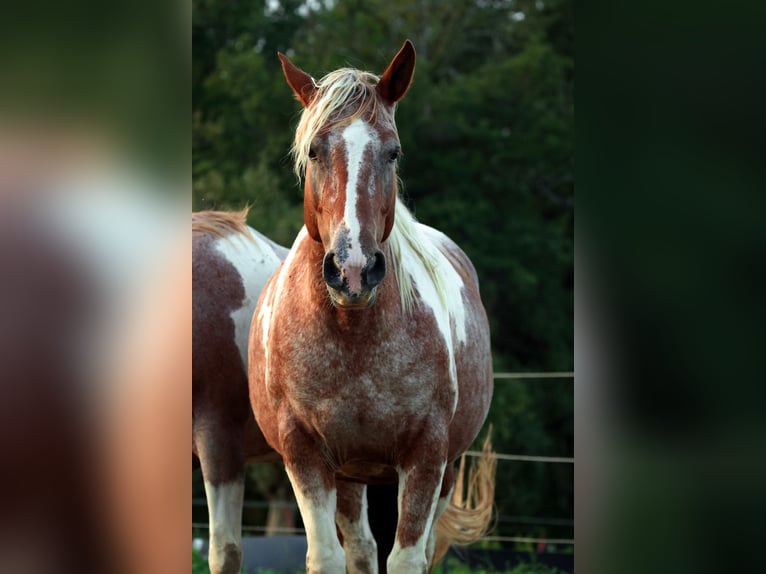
[282,429,346,574]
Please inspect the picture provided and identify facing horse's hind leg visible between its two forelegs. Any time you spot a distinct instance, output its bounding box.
[335,480,378,574]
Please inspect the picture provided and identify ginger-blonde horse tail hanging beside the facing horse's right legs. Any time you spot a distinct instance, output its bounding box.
[431,427,497,569]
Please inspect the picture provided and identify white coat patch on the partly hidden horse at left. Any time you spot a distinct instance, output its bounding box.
[215,230,281,370]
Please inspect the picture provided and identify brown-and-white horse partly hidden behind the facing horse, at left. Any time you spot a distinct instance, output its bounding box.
[192,210,288,574]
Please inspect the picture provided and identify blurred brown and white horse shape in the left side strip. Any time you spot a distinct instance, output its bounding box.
[0,161,191,574]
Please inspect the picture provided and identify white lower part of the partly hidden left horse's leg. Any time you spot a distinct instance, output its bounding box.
[205,480,245,574]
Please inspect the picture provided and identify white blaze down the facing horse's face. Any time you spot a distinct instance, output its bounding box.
[342,119,380,266]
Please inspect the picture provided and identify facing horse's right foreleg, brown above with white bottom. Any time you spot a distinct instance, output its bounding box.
[387,460,446,574]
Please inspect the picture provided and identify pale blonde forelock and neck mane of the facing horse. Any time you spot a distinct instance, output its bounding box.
[291,68,451,315]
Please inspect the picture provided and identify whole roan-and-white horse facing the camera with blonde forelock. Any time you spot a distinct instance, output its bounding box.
[248,40,494,574]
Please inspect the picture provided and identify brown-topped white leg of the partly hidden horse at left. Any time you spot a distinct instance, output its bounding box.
[197,432,245,574]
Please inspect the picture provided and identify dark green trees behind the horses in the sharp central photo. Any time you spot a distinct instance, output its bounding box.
[192,0,574,552]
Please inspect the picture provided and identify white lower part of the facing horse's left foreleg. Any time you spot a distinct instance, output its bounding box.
[287,470,346,574]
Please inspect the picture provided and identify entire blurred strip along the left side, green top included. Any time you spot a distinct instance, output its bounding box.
[0,2,191,574]
